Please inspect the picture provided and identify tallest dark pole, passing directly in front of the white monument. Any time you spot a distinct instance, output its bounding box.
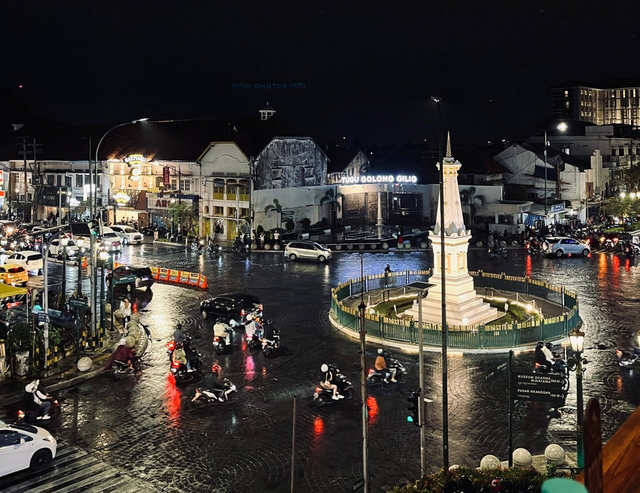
[431,96,449,469]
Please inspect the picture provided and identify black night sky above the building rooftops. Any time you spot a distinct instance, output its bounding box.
[0,0,640,144]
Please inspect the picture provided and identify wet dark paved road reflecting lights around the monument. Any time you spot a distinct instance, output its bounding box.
[0,244,640,492]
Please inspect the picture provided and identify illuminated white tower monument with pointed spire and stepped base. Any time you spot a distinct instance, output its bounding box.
[405,136,498,326]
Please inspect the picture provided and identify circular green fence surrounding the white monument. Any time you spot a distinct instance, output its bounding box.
[331,269,581,349]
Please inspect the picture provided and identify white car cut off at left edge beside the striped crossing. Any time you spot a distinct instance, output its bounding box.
[0,421,58,476]
